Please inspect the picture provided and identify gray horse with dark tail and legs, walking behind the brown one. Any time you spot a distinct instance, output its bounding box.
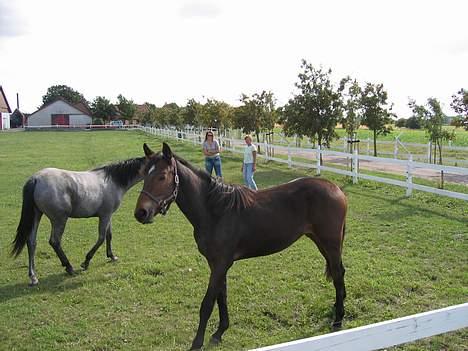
[11,157,146,286]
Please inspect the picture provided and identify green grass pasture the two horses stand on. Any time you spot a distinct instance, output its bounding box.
[0,131,468,351]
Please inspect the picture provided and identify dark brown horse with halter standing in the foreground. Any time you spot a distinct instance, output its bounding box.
[135,143,347,350]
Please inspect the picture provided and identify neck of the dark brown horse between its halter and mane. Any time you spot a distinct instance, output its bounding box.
[176,162,208,229]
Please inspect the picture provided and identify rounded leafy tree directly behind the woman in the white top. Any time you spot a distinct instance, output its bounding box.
[234,90,278,142]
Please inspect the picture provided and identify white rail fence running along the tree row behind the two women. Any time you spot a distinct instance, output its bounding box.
[141,127,468,201]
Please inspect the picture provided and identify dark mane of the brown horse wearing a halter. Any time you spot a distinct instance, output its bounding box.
[174,155,255,215]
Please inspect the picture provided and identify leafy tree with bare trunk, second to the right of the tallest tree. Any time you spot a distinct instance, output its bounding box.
[360,83,393,156]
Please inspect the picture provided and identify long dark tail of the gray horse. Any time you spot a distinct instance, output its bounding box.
[11,177,36,257]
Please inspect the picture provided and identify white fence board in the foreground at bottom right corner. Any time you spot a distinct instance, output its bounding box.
[252,303,468,351]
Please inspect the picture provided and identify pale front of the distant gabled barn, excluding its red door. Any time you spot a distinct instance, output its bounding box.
[28,100,92,127]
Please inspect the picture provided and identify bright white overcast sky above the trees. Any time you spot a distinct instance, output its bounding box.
[0,0,468,117]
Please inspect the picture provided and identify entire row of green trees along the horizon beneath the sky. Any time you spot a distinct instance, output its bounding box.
[43,60,468,162]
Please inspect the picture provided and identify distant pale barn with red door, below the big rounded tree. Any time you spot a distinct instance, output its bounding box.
[27,98,92,127]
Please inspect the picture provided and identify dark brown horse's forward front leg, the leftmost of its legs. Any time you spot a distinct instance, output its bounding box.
[190,262,232,350]
